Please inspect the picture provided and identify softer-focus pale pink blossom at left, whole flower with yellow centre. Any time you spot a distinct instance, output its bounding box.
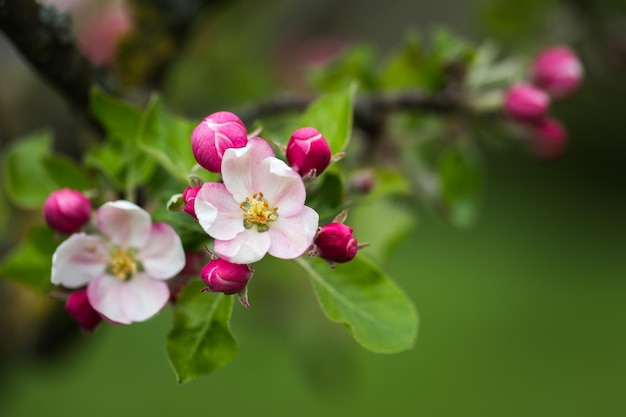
[52,201,185,324]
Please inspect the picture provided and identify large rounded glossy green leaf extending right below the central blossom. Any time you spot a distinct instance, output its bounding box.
[296,255,418,353]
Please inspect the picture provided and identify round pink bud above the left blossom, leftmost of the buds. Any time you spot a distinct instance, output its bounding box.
[43,188,91,234]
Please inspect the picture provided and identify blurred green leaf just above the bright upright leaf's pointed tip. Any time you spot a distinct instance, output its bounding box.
[310,45,377,92]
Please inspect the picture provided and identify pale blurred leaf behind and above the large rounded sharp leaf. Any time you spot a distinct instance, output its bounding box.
[347,199,417,264]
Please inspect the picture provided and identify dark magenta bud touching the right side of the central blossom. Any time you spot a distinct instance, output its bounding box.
[313,222,359,263]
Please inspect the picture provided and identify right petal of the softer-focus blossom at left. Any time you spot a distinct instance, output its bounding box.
[139,222,185,279]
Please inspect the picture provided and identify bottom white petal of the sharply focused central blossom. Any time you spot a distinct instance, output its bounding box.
[214,227,271,264]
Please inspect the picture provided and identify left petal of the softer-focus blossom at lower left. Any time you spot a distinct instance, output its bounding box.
[51,233,108,288]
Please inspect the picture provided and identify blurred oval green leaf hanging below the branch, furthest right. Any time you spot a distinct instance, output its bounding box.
[437,141,484,227]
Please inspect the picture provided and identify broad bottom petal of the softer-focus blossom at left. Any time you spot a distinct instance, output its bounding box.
[87,273,170,324]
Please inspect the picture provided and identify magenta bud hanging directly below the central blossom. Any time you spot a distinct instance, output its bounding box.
[200,258,252,295]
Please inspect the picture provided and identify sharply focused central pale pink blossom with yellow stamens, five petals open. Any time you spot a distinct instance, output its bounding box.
[195,138,319,264]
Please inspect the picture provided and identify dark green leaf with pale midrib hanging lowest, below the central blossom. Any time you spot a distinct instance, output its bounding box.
[166,280,238,384]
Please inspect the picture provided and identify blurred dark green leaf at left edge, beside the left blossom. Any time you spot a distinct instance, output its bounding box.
[0,226,58,293]
